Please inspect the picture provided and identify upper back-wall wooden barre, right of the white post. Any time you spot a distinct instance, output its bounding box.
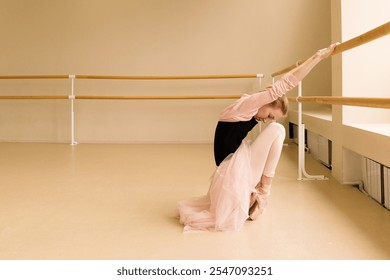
[76,74,264,80]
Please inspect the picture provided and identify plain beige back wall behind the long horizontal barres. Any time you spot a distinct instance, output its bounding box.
[0,0,331,142]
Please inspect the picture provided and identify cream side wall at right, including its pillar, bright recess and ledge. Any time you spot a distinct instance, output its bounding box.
[331,0,390,182]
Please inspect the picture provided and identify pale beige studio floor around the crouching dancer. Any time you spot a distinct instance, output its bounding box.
[0,143,390,260]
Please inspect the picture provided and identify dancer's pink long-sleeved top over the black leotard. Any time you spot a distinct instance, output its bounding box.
[219,73,299,122]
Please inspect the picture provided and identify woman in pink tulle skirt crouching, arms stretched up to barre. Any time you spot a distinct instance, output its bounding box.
[178,44,337,231]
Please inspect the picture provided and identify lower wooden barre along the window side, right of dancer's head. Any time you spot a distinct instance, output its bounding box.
[288,96,390,109]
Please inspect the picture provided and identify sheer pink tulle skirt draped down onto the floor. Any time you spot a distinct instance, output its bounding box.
[178,141,256,231]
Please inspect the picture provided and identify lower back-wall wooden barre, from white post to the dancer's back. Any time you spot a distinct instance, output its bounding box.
[75,95,240,100]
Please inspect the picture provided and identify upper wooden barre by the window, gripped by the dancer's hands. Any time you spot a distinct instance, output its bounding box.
[271,21,390,77]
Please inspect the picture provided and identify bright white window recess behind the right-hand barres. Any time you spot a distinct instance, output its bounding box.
[341,0,390,124]
